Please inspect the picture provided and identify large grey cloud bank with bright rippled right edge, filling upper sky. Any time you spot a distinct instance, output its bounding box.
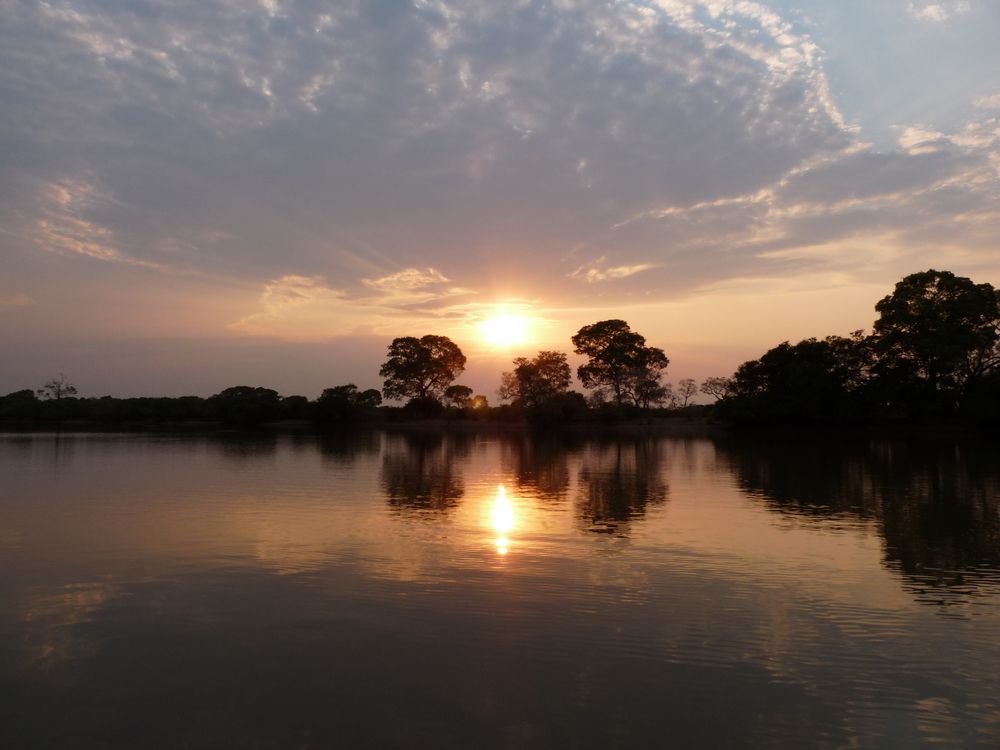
[0,0,850,294]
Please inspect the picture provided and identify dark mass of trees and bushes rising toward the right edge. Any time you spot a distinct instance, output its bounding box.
[716,269,1000,424]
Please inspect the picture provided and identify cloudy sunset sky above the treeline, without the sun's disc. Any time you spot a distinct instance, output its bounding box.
[0,0,1000,400]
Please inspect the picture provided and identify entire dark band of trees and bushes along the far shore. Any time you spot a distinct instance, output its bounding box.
[0,270,1000,427]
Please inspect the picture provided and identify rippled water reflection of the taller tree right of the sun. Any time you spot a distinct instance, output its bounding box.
[577,439,668,536]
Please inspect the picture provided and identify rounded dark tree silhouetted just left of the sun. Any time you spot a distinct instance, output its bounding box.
[379,335,465,401]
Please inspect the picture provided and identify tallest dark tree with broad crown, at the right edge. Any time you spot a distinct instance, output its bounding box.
[872,269,1000,406]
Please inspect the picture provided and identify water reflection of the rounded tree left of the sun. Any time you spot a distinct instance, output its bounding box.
[381,433,471,511]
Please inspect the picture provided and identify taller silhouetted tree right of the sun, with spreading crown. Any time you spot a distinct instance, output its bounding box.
[573,320,670,406]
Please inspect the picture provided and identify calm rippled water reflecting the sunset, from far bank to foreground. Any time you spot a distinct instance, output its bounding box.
[0,433,1000,749]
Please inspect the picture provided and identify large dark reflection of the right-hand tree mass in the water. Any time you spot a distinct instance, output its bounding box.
[718,437,1000,604]
